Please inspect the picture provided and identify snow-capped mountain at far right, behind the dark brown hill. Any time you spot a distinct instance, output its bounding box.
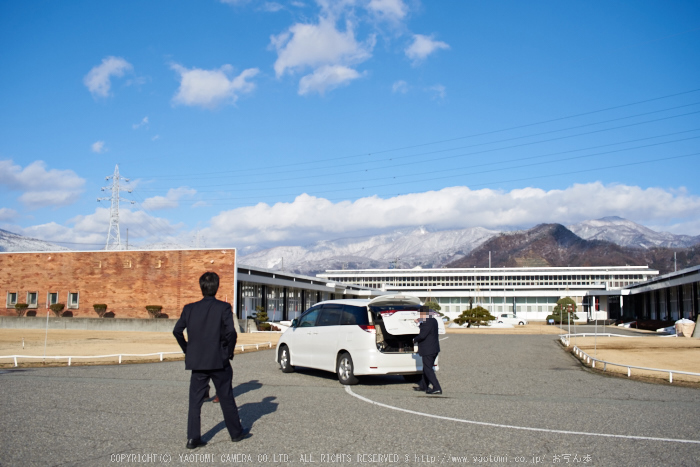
[567,216,700,248]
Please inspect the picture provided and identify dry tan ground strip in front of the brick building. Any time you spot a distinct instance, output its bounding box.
[0,329,280,368]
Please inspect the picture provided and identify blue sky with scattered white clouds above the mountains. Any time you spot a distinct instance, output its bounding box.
[0,0,700,249]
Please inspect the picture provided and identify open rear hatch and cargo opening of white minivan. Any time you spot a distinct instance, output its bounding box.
[369,295,421,353]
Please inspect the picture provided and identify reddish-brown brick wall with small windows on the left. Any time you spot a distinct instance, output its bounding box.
[0,249,236,318]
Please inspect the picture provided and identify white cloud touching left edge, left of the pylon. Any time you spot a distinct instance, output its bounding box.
[0,160,85,208]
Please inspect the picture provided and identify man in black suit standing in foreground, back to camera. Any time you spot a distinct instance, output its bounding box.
[173,272,249,449]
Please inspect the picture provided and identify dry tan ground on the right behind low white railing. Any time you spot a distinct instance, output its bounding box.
[571,336,700,383]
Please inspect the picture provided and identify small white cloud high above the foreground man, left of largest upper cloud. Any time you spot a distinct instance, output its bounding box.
[171,64,260,108]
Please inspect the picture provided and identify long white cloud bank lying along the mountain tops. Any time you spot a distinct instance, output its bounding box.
[201,182,700,247]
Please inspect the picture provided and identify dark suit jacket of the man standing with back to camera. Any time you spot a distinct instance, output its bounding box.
[173,297,238,370]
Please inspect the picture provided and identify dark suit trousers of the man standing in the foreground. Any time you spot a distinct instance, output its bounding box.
[187,362,243,439]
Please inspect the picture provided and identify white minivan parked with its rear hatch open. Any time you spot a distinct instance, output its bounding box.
[275,295,445,384]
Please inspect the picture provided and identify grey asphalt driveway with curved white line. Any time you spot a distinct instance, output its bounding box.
[0,335,700,466]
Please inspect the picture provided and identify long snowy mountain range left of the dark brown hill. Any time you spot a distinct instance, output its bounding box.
[239,227,499,274]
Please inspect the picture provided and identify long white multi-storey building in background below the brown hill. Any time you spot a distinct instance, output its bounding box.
[317,266,659,321]
